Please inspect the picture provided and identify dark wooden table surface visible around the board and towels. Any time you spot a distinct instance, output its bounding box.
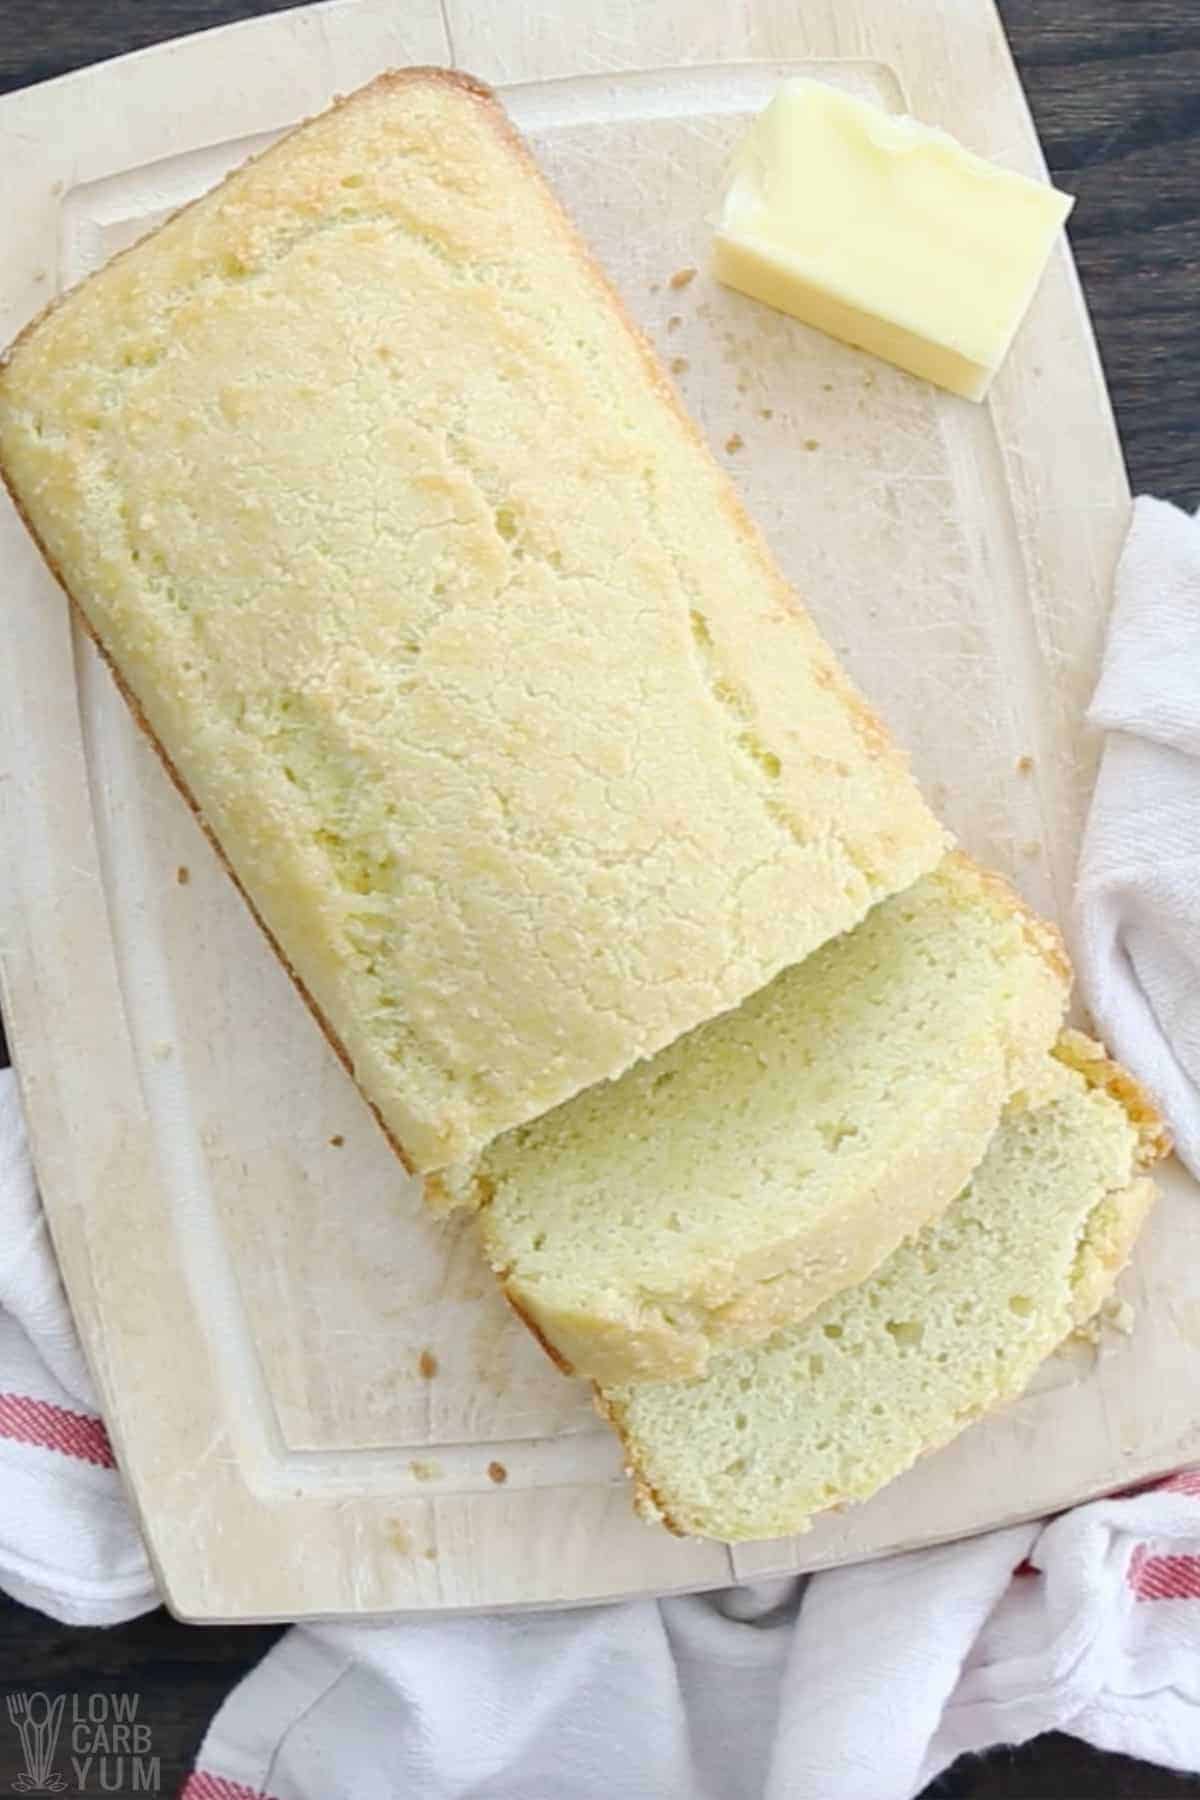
[0,0,1200,1800]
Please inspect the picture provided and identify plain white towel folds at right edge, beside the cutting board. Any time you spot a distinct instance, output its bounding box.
[1074,499,1200,1177]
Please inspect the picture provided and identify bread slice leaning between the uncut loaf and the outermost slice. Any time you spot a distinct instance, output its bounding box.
[455,853,1069,1381]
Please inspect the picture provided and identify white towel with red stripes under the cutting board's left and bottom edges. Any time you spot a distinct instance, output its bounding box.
[0,1075,1200,1800]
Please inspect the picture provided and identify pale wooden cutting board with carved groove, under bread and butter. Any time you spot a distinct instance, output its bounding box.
[0,0,1200,1620]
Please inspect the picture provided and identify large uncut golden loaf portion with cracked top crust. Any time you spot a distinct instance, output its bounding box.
[0,68,945,1170]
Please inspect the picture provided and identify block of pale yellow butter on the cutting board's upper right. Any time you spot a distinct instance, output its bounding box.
[714,81,1074,400]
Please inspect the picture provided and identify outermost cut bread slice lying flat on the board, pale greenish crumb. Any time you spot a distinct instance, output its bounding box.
[599,1033,1169,1541]
